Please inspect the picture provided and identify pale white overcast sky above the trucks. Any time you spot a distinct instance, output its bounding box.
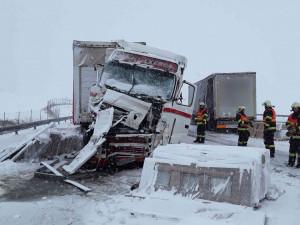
[0,0,300,114]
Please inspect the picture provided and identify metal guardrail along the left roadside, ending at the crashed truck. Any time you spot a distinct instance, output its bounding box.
[0,116,72,134]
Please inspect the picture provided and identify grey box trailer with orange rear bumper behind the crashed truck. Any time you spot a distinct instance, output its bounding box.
[189,72,256,130]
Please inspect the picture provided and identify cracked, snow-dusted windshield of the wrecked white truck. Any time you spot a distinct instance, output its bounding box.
[100,61,175,99]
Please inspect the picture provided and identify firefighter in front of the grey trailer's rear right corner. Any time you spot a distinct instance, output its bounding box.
[236,106,253,146]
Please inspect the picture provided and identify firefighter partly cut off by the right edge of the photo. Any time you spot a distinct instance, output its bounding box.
[286,102,300,168]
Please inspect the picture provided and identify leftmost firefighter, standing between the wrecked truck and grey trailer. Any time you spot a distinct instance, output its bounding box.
[194,102,208,143]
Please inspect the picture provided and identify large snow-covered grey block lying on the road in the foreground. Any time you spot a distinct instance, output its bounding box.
[133,144,270,207]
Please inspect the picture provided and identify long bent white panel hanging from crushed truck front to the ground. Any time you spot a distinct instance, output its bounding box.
[63,108,114,174]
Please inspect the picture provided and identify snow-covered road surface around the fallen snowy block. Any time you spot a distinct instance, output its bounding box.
[0,125,300,225]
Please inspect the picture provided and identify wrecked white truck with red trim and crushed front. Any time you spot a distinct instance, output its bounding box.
[63,40,196,174]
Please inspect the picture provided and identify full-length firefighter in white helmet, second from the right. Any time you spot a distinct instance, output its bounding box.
[262,100,276,158]
